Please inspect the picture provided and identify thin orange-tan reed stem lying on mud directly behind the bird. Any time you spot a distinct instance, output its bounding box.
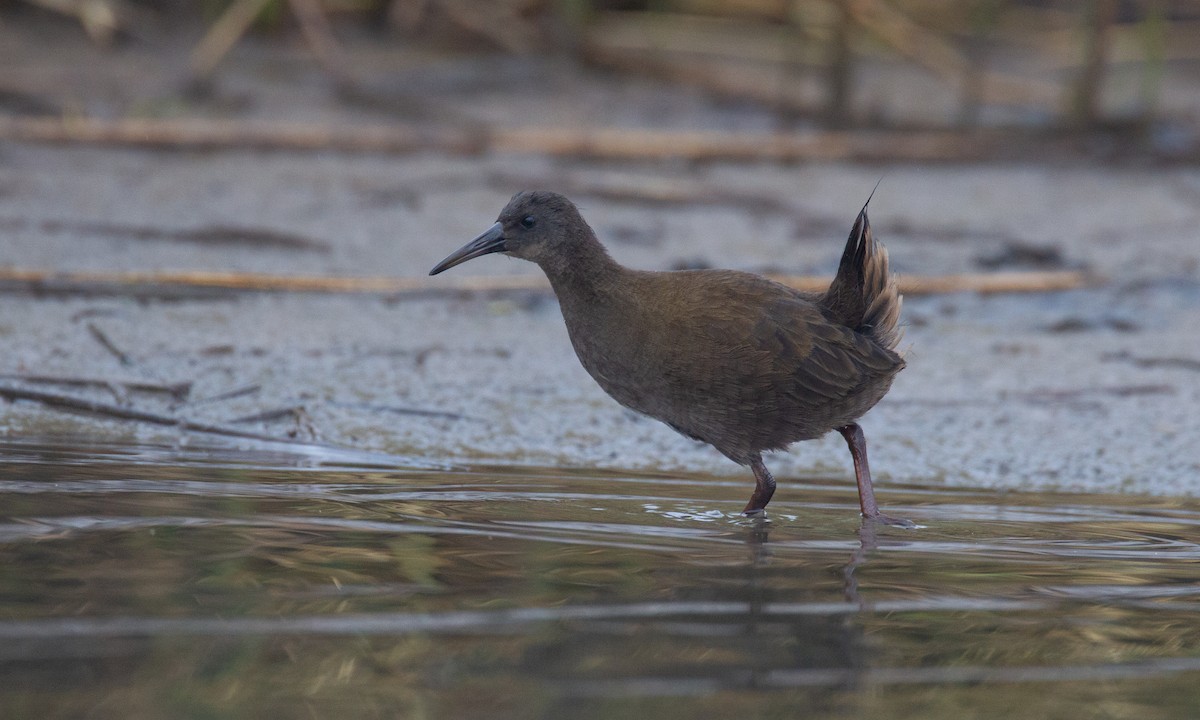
[0,268,1099,295]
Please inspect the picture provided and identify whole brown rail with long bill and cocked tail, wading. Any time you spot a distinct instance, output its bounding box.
[430,191,911,524]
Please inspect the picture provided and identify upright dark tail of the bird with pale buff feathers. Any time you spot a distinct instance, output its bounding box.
[822,191,904,350]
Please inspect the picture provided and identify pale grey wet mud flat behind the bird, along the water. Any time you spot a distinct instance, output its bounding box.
[0,21,1200,504]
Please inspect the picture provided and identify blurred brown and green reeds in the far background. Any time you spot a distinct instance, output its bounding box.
[0,0,1200,158]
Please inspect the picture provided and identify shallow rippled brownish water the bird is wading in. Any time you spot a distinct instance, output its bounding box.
[0,436,1200,719]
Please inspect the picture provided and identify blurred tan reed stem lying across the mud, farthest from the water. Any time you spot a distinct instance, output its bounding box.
[0,116,1043,162]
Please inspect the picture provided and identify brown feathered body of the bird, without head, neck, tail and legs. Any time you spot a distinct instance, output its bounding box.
[560,270,904,462]
